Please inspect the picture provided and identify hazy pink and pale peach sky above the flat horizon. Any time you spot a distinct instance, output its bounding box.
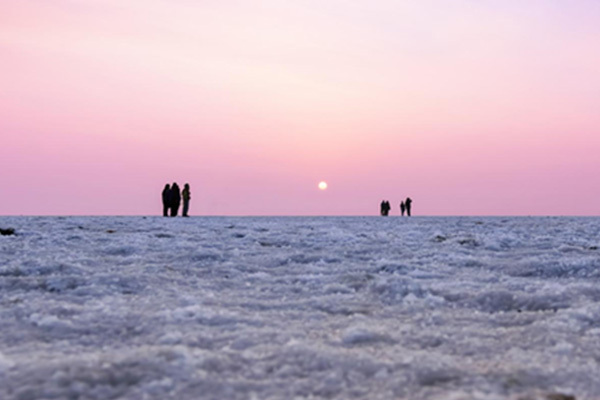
[0,0,600,215]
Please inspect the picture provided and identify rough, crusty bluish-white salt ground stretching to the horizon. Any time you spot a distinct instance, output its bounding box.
[0,217,600,400]
